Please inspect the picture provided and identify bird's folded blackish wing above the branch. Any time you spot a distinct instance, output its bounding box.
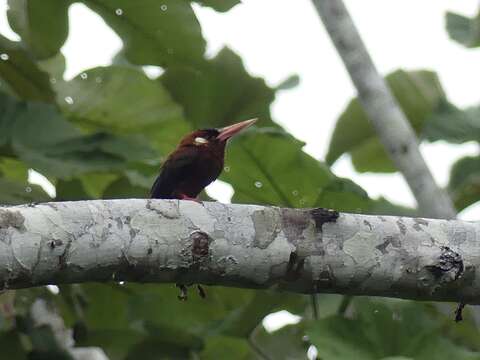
[150,147,199,199]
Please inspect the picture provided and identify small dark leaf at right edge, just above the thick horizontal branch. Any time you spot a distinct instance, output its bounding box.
[448,156,480,211]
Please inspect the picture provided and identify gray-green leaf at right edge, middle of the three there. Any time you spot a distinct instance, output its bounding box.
[422,103,480,144]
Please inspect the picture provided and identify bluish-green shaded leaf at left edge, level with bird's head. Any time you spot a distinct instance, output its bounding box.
[0,93,154,178]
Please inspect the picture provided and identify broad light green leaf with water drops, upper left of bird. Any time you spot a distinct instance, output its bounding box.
[58,66,190,152]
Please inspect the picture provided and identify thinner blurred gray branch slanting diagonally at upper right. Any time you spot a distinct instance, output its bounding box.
[312,0,455,219]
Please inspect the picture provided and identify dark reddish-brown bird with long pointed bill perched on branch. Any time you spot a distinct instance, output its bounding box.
[150,119,257,201]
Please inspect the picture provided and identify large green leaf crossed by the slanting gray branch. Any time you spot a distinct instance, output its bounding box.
[326,70,445,172]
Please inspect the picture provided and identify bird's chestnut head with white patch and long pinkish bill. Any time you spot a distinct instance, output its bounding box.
[180,119,257,149]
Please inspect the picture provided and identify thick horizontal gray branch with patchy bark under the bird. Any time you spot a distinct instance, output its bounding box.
[0,200,480,304]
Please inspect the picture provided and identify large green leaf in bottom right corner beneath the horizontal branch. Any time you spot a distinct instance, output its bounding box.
[307,298,480,360]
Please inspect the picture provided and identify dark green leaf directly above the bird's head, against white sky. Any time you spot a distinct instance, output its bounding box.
[160,48,276,129]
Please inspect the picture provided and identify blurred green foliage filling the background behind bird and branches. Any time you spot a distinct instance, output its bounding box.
[0,0,480,360]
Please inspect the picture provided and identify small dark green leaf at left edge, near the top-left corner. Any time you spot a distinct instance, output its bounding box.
[0,35,55,102]
